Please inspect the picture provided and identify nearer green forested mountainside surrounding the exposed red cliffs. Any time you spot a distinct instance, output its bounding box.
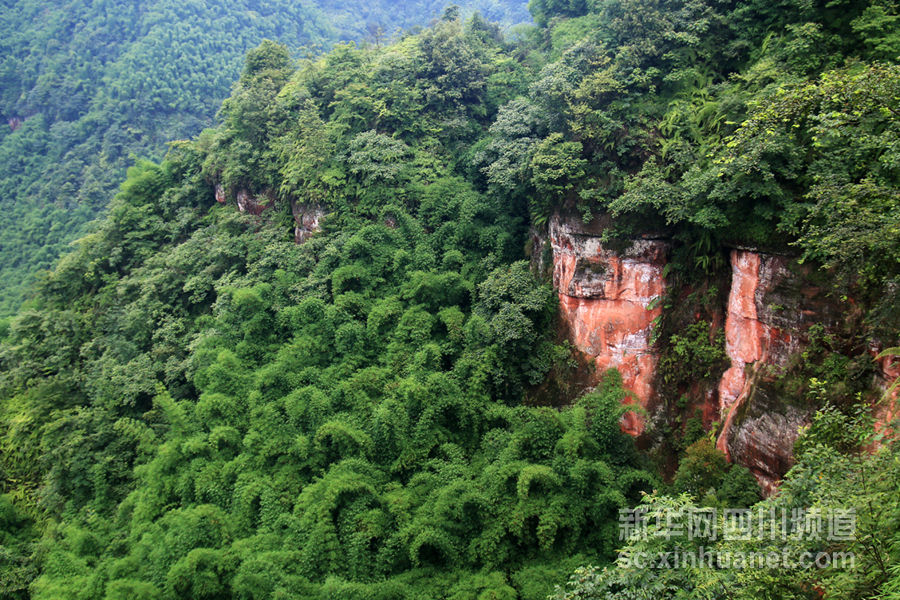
[0,0,900,600]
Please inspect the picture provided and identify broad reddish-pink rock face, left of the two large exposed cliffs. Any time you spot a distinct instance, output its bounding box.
[549,215,669,435]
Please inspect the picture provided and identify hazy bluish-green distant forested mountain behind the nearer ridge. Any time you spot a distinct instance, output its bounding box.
[0,0,528,315]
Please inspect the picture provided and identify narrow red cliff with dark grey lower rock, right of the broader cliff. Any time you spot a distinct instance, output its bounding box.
[717,250,841,493]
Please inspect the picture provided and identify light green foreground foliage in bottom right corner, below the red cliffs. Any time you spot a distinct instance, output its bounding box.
[553,405,900,600]
